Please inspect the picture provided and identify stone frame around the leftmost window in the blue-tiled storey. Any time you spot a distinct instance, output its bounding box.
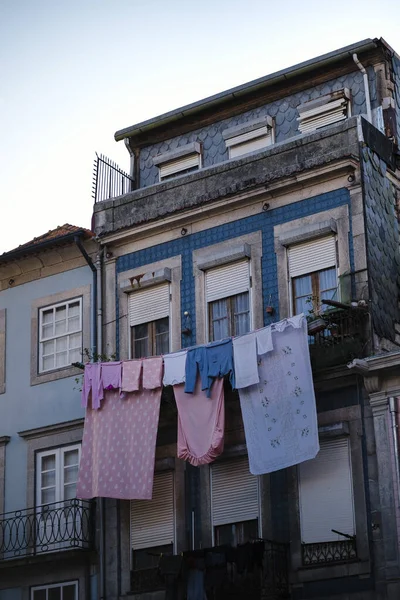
[117,254,182,360]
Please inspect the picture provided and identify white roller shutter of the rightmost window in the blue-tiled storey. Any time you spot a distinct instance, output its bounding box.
[288,235,336,277]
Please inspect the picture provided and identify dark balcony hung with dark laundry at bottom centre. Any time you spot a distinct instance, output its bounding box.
[131,540,290,600]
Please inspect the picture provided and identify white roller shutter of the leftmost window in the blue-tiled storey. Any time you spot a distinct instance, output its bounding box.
[128,283,169,327]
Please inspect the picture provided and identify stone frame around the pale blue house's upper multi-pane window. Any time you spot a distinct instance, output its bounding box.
[31,285,91,385]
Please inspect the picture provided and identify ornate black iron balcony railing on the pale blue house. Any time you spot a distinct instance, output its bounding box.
[0,499,94,560]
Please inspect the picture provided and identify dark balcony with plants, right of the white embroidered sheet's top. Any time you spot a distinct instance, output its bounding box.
[308,303,368,371]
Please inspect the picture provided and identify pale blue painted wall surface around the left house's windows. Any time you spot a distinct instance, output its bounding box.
[0,267,92,512]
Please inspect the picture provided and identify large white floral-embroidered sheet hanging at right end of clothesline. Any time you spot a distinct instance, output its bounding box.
[239,316,319,475]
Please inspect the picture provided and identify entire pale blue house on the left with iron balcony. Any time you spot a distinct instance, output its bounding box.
[0,225,97,600]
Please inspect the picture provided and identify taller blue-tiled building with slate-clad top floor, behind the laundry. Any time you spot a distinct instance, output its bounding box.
[90,40,400,600]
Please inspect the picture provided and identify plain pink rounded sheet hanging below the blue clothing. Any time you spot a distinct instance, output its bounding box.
[174,377,225,467]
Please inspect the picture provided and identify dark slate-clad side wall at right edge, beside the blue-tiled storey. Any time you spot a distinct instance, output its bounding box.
[362,145,400,344]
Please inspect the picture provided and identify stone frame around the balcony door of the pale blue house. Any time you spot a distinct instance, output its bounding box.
[18,419,84,508]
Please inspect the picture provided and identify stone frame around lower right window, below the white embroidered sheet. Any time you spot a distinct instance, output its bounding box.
[288,405,371,584]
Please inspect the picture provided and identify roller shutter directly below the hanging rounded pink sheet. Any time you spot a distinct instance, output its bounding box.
[211,457,259,527]
